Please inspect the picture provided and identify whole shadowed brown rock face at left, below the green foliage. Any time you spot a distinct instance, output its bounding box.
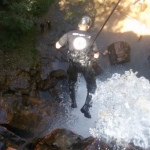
[0,61,67,143]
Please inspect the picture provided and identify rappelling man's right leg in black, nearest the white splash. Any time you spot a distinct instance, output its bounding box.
[81,68,96,118]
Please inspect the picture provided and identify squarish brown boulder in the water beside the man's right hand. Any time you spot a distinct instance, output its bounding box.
[107,41,131,65]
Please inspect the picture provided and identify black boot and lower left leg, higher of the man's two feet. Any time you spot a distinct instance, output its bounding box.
[69,83,77,108]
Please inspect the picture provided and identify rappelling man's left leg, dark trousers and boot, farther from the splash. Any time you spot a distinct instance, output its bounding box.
[68,65,77,108]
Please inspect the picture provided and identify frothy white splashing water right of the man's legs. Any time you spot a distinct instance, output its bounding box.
[89,70,150,148]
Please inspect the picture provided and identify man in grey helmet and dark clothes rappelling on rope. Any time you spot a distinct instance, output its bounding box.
[55,16,100,118]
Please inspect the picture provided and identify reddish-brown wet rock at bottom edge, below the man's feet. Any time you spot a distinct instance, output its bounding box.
[31,128,108,150]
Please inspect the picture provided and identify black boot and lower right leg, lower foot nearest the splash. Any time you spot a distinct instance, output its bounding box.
[81,93,92,118]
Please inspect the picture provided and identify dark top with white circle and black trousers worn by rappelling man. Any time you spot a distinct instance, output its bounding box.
[59,30,98,118]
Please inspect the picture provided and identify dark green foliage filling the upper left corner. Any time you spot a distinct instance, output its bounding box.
[0,0,54,65]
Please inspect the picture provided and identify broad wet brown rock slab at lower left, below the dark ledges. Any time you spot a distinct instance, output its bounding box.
[0,94,64,137]
